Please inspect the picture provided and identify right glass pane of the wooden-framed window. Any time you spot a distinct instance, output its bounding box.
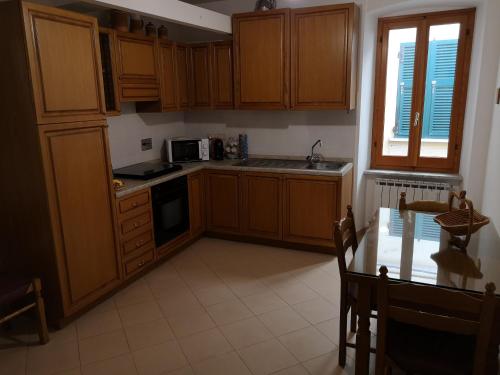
[420,23,460,158]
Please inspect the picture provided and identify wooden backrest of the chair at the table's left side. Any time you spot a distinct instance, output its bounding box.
[333,206,358,277]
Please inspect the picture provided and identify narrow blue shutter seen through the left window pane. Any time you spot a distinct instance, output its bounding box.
[394,43,415,138]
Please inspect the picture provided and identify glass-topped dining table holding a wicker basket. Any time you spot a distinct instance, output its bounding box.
[346,208,500,375]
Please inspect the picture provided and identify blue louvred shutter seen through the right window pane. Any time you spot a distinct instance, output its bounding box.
[422,39,458,139]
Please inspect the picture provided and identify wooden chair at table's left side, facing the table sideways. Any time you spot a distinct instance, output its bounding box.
[334,206,358,367]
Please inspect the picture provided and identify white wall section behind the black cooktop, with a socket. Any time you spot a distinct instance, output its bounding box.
[108,103,185,168]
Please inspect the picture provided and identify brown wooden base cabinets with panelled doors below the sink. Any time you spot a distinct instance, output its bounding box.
[206,171,352,249]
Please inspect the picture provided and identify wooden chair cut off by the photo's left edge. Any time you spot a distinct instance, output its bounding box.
[0,273,49,345]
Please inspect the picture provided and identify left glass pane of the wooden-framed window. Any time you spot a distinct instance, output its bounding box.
[382,27,417,156]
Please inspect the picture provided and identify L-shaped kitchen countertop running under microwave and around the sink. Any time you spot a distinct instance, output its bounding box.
[116,160,353,198]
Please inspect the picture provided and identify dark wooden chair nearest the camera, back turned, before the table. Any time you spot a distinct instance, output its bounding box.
[375,266,497,375]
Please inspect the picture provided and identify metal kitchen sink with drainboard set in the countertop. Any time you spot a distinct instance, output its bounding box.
[234,159,347,171]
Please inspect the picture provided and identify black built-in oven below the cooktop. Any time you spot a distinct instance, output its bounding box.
[151,176,189,247]
